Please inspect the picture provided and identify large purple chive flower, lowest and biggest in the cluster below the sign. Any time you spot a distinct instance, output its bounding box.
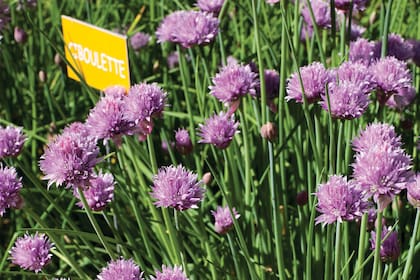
[39,130,101,188]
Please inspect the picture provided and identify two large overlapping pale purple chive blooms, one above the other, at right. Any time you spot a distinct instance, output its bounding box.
[352,124,413,210]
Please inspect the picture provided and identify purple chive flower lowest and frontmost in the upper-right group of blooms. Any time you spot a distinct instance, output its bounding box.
[321,81,370,120]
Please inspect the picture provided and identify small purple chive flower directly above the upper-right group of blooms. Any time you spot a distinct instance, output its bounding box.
[349,38,379,65]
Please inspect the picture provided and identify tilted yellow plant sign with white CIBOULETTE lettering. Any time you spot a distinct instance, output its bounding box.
[61,15,130,90]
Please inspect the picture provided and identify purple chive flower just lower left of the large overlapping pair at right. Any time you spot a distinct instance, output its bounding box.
[316,175,368,225]
